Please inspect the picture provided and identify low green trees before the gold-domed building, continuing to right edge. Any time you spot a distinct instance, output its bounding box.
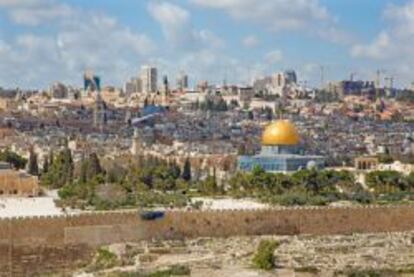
[226,168,414,206]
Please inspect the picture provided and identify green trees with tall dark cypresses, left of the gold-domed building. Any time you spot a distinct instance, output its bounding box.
[48,150,193,209]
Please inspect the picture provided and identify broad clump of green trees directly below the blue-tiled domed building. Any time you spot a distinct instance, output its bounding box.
[227,167,366,206]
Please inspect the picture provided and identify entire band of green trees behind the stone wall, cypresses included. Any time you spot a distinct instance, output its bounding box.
[41,148,414,209]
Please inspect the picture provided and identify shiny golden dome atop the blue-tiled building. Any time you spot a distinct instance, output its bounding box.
[262,120,300,145]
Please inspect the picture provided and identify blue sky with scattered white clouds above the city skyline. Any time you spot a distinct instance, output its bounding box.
[0,0,414,89]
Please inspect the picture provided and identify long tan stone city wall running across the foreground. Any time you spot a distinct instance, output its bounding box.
[0,206,414,276]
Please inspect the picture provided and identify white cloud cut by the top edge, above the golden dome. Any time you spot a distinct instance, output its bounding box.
[190,0,352,43]
